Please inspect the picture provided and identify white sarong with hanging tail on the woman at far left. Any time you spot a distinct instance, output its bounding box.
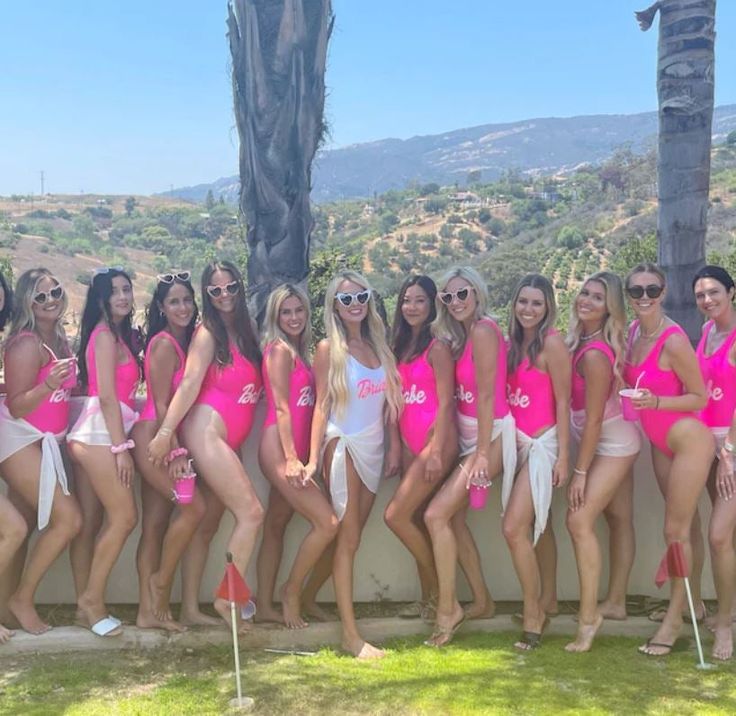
[0,400,69,530]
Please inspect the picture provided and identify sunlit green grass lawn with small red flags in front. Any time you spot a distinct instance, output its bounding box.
[0,634,736,716]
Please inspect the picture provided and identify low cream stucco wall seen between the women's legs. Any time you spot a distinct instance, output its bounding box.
[2,406,714,603]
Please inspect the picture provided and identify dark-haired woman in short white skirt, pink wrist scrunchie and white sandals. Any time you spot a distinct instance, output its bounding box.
[66,268,140,636]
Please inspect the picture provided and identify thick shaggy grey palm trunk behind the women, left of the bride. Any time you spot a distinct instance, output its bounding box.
[228,0,334,315]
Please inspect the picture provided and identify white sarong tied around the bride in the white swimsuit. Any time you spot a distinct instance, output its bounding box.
[322,418,383,521]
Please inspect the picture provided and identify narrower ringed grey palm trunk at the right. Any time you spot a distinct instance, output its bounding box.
[636,0,716,340]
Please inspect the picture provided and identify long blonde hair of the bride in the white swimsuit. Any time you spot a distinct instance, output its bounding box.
[325,271,404,419]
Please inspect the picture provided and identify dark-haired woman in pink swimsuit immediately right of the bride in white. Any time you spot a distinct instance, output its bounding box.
[384,276,458,621]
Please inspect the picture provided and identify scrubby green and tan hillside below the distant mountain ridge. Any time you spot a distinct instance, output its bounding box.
[0,146,736,332]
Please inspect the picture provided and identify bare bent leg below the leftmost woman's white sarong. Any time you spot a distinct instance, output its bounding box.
[2,442,82,634]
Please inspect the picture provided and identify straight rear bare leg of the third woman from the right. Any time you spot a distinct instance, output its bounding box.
[598,466,636,620]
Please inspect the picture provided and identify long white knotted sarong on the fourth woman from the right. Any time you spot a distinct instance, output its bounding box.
[501,425,558,544]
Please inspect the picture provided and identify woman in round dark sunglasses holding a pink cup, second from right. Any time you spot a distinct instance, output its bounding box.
[624,263,715,656]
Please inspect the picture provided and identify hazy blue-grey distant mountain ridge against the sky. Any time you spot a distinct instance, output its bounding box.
[163,104,736,203]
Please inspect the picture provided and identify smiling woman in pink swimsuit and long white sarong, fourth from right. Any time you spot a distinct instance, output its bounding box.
[501,274,571,650]
